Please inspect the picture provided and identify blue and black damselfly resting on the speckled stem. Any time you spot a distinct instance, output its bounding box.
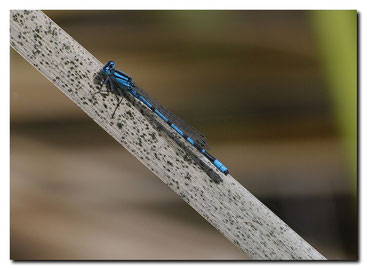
[100,61,229,175]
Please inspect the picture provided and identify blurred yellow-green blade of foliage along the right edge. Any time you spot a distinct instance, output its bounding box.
[312,10,357,195]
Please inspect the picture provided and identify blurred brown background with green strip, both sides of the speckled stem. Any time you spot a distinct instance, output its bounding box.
[10,11,358,260]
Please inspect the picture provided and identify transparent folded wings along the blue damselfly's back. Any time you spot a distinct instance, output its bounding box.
[134,85,209,150]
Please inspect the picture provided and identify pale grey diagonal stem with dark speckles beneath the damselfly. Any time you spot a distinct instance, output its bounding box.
[10,10,325,260]
